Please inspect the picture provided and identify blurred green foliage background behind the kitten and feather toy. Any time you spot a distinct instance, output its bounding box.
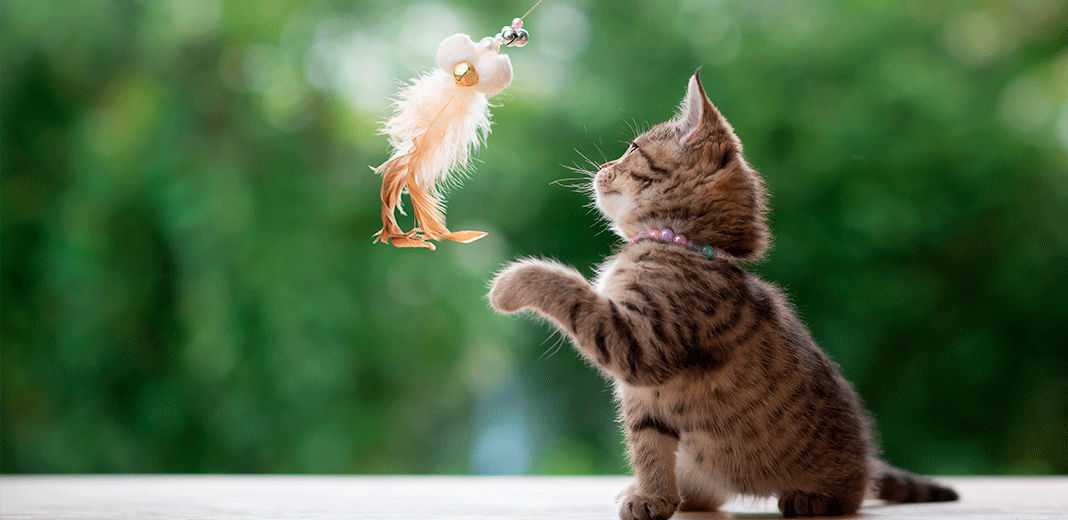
[0,0,1068,474]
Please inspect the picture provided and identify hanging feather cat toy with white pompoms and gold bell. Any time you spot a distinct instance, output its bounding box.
[372,0,541,251]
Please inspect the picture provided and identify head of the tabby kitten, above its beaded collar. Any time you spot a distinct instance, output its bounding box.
[594,74,768,259]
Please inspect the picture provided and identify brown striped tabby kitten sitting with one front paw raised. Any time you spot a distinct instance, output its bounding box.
[489,74,957,520]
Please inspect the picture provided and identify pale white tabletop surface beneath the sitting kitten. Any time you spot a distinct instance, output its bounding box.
[0,475,1068,520]
